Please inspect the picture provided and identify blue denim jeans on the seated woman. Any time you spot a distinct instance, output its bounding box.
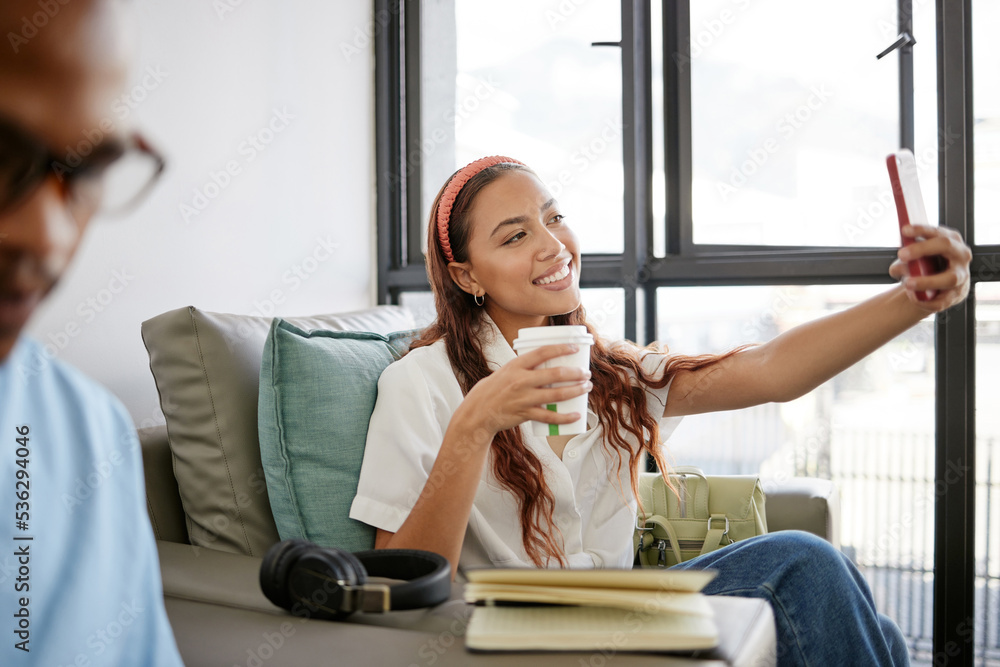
[675,531,910,667]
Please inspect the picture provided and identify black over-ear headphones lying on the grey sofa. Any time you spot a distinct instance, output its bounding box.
[260,540,451,621]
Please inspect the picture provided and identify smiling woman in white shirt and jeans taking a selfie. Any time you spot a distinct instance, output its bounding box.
[358,156,970,665]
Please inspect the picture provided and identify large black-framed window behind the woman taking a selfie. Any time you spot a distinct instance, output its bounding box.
[376,0,1000,665]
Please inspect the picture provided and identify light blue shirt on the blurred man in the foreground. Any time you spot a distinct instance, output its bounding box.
[0,337,183,667]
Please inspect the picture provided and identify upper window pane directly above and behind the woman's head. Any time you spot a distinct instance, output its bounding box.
[420,0,624,253]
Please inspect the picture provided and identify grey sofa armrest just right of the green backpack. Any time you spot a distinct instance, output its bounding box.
[762,477,840,549]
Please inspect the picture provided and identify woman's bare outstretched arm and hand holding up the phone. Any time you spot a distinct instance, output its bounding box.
[664,226,972,417]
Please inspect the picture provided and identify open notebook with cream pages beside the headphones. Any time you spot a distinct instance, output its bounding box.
[465,569,718,651]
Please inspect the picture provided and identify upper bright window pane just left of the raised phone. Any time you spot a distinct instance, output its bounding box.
[692,0,904,246]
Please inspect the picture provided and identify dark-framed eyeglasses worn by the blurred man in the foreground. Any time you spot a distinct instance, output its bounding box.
[0,113,166,222]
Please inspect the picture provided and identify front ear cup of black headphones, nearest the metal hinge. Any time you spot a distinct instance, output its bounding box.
[287,547,368,621]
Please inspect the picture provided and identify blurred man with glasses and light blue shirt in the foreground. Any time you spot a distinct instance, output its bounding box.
[0,0,182,666]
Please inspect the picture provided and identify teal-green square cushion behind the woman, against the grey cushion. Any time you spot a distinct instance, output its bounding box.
[257,318,416,551]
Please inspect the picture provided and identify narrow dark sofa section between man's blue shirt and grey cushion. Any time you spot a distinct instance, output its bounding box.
[139,426,189,544]
